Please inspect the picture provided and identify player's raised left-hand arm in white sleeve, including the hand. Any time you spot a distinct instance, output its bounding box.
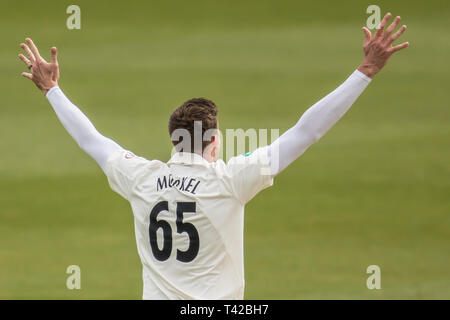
[19,38,122,171]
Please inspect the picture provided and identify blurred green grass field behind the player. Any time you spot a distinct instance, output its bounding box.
[0,0,450,299]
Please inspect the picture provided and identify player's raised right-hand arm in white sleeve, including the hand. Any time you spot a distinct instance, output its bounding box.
[268,13,409,176]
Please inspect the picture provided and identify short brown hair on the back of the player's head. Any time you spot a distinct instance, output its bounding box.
[169,98,217,153]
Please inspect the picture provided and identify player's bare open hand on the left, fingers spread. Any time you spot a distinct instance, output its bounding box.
[19,38,59,94]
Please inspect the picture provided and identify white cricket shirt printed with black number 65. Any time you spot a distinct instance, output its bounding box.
[105,149,273,299]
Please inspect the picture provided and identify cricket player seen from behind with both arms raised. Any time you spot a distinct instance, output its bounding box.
[19,13,409,299]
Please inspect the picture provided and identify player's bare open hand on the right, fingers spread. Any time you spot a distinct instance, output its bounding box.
[358,13,409,78]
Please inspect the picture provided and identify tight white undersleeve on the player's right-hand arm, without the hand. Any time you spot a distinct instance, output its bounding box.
[268,70,372,176]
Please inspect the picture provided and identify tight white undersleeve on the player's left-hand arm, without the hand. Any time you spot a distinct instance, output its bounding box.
[46,86,122,171]
